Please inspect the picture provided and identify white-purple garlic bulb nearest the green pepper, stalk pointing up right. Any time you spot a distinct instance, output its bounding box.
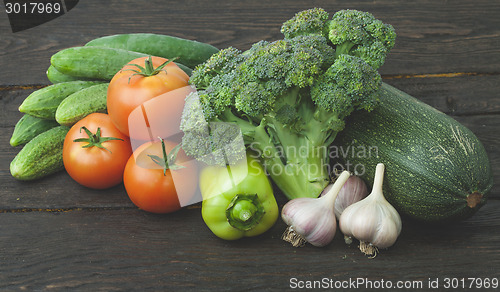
[281,171,350,247]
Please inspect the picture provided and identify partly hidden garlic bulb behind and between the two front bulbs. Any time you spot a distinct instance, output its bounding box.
[321,175,368,219]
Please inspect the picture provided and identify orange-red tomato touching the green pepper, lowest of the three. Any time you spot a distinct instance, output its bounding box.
[123,140,198,213]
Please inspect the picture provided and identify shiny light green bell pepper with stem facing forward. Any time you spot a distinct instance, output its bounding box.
[200,155,279,240]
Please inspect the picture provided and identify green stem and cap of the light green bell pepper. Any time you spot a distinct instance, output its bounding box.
[226,194,265,231]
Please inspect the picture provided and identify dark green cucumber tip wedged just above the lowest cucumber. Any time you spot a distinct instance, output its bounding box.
[10,115,59,147]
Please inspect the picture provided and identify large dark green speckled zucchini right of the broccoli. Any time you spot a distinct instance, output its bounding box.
[334,83,493,222]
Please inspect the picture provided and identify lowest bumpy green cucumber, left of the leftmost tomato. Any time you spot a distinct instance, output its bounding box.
[10,126,69,180]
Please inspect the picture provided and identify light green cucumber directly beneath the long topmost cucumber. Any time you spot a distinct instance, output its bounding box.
[50,46,192,81]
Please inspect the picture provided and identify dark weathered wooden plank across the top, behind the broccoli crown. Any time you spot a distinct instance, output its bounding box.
[0,0,500,85]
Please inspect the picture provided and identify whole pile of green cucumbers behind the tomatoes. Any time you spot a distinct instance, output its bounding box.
[10,33,219,180]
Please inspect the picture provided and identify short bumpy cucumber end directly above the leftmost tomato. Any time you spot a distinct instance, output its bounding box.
[56,83,109,126]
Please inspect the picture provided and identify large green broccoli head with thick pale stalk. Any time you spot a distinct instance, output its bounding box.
[181,8,394,199]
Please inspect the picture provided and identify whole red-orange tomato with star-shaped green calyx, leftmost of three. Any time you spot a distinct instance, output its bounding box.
[63,113,132,189]
